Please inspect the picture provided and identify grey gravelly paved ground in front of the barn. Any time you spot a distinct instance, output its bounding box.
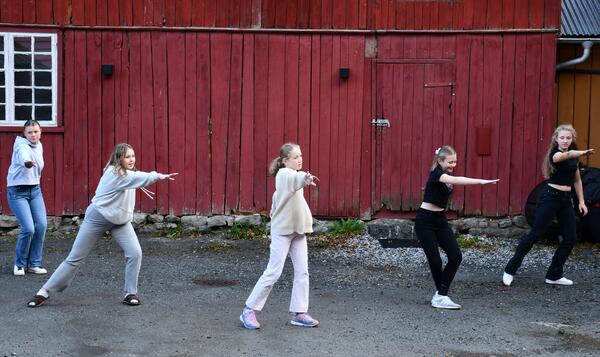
[0,237,600,356]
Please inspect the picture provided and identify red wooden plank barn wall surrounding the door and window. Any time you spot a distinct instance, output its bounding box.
[0,0,559,216]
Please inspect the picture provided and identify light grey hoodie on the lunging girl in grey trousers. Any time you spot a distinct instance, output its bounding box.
[92,165,160,224]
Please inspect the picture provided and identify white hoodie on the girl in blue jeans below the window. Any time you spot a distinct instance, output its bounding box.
[6,136,44,187]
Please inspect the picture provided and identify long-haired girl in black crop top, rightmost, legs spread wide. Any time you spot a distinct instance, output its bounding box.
[502,125,594,286]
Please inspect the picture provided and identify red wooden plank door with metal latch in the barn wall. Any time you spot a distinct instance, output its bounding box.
[371,60,455,213]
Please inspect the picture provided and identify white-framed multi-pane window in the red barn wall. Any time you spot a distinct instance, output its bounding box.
[0,32,58,126]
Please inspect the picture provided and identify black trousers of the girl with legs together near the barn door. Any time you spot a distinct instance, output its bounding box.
[415,208,462,295]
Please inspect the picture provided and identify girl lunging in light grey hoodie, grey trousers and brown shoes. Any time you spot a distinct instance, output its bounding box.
[27,144,177,307]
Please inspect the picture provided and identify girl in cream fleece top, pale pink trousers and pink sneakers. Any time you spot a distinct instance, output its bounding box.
[240,143,319,330]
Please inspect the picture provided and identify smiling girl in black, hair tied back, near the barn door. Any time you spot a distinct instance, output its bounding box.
[415,145,498,309]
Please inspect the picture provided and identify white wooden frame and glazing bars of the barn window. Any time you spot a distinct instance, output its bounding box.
[0,32,58,127]
